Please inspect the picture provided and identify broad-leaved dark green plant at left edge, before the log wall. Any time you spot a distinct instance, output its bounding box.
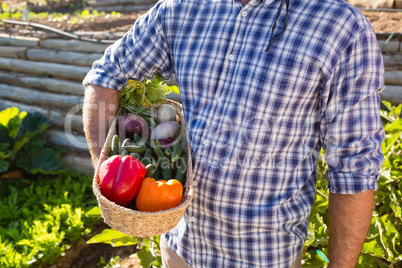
[0,107,66,176]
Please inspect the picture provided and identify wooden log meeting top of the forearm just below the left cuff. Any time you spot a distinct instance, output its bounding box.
[0,71,84,96]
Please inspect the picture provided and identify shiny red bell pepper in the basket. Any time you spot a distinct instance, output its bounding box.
[98,155,147,206]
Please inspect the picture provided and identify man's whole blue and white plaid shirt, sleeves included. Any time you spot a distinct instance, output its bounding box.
[83,0,384,268]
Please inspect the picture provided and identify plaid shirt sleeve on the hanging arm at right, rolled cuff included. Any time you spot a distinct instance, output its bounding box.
[320,28,384,194]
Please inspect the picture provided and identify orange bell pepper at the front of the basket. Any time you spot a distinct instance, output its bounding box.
[136,178,183,212]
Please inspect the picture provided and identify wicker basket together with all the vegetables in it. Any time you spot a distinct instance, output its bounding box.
[93,77,193,237]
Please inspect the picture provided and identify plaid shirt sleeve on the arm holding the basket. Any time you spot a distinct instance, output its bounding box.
[83,1,173,90]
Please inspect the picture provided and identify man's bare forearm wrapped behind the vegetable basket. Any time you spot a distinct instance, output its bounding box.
[82,85,120,168]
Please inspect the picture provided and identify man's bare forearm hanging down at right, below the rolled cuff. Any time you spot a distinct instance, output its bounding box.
[329,190,374,268]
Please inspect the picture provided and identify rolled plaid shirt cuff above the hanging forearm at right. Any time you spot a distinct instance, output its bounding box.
[327,172,381,194]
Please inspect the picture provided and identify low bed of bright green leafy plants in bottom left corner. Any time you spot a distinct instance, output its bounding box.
[0,173,99,268]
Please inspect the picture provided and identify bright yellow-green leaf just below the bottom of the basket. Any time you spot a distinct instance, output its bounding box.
[87,229,138,247]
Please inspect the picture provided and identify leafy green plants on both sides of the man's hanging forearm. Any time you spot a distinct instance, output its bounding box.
[303,102,402,268]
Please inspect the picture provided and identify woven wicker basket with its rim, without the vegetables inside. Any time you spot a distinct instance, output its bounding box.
[92,100,193,237]
